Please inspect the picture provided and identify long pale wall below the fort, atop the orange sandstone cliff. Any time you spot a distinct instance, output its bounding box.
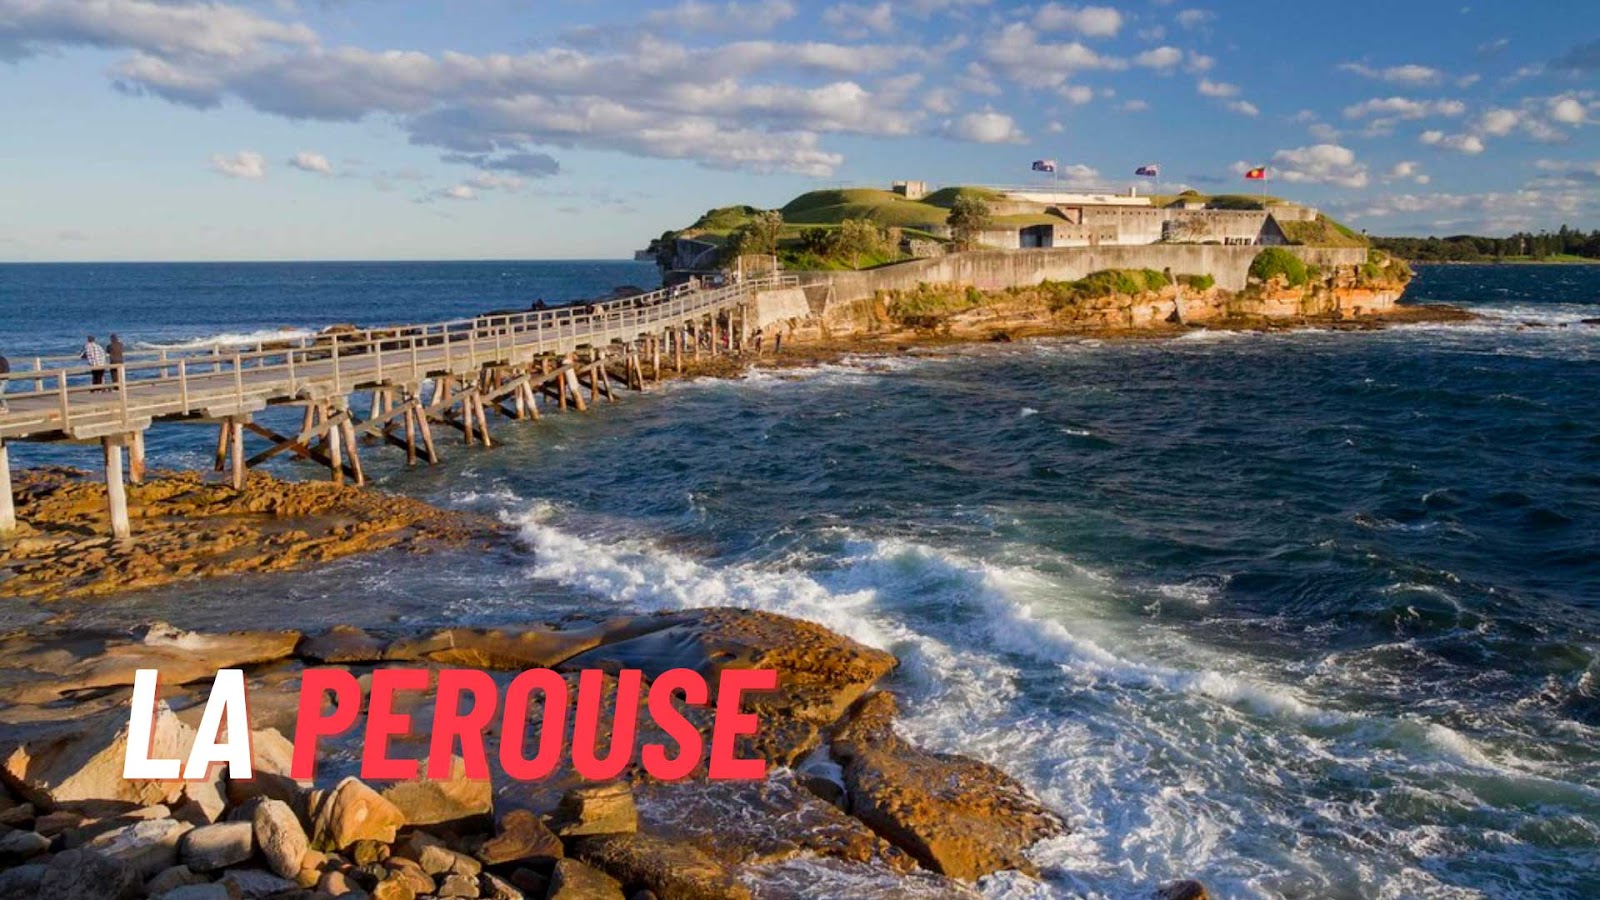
[792,243,1366,304]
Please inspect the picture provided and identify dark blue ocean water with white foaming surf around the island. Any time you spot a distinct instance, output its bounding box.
[0,264,1600,898]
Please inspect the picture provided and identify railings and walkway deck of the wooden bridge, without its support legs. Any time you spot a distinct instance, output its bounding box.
[0,275,798,432]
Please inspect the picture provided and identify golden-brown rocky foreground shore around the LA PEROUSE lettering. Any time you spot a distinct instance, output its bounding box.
[0,609,1203,900]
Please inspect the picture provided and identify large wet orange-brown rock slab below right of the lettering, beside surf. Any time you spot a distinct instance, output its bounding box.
[832,693,1066,881]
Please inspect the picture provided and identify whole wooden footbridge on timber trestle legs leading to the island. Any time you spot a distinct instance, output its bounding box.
[0,275,795,538]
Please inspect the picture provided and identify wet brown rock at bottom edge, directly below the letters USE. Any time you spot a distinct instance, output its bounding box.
[571,834,750,900]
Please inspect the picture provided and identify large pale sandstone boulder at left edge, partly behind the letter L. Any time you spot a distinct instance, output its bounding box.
[0,701,194,809]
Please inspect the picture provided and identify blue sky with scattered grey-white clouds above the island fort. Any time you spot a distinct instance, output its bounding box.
[0,0,1600,261]
